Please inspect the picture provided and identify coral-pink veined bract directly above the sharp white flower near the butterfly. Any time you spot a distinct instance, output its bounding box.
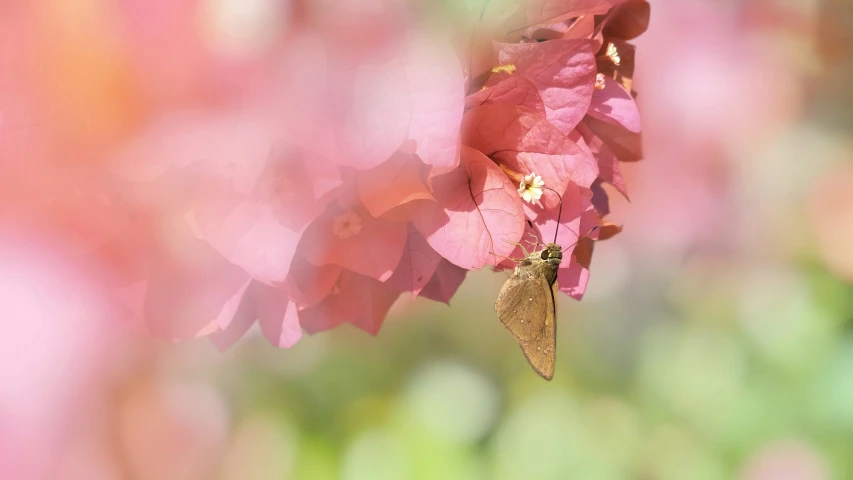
[462,105,598,208]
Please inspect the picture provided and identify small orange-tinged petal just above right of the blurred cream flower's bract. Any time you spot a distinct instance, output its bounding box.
[356,152,432,217]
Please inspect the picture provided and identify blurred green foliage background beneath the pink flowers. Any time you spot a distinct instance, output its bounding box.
[208,255,853,479]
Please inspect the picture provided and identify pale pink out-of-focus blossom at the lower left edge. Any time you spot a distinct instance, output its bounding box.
[0,234,115,479]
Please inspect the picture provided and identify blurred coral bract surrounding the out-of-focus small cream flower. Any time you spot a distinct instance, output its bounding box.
[300,204,407,281]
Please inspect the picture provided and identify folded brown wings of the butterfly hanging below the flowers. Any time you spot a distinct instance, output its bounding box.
[495,263,557,380]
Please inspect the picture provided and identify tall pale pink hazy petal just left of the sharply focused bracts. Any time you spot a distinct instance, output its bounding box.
[403,34,465,173]
